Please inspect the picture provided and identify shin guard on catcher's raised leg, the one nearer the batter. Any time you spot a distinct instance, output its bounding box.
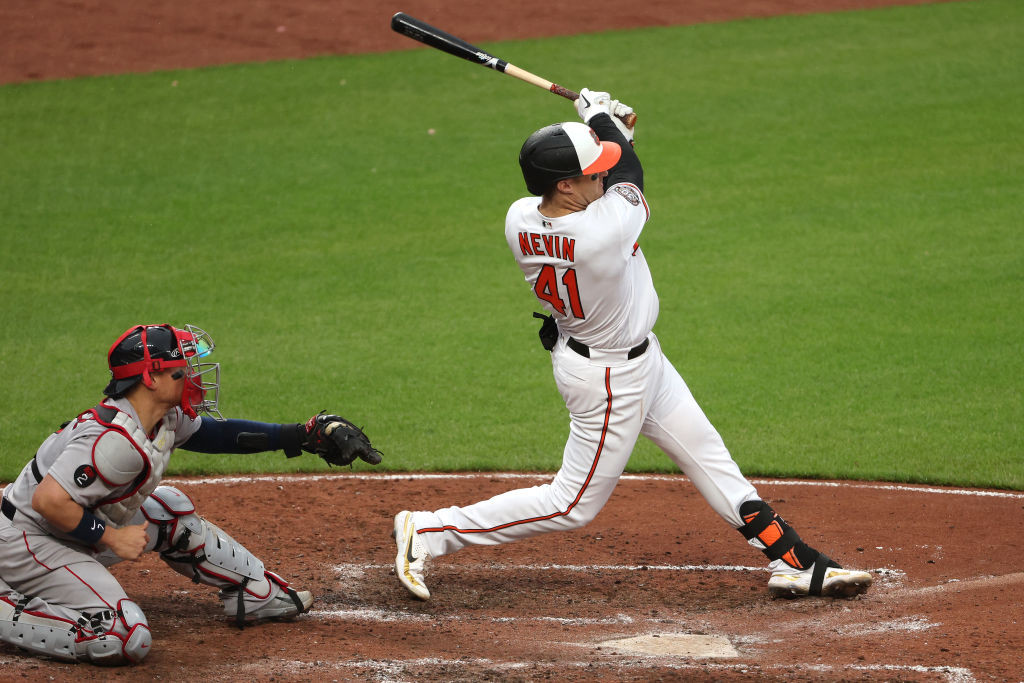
[142,486,271,597]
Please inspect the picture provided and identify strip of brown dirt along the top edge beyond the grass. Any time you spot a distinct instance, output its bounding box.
[0,0,954,83]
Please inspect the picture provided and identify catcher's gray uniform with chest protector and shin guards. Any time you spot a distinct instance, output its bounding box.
[0,398,308,664]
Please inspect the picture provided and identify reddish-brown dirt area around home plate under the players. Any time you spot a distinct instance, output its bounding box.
[0,474,1024,682]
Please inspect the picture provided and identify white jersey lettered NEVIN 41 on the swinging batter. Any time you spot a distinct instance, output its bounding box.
[505,182,657,349]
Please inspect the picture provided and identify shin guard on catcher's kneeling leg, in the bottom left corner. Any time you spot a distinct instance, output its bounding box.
[0,595,153,666]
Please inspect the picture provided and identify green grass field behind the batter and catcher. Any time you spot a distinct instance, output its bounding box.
[0,0,1024,489]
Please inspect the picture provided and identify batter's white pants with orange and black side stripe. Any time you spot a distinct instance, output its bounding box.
[413,333,758,557]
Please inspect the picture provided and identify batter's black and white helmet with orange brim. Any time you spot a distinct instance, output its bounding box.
[519,121,623,195]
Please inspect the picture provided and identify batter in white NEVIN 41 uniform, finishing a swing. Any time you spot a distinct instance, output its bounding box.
[394,89,871,600]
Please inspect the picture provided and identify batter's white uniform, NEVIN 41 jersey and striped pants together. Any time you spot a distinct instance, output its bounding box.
[413,182,757,557]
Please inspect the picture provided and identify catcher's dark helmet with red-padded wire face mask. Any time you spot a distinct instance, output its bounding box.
[103,325,223,420]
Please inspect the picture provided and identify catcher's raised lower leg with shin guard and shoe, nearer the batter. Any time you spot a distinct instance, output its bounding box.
[142,486,313,628]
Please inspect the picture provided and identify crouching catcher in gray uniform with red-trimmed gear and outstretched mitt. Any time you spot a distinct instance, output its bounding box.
[0,325,381,665]
